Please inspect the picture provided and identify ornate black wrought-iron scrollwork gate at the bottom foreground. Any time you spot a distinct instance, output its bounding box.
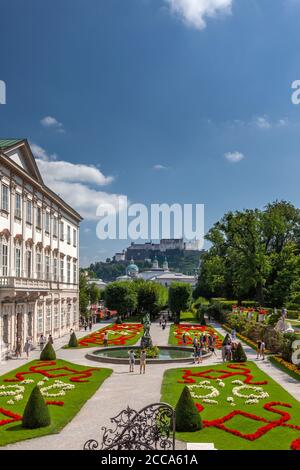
[84,403,175,450]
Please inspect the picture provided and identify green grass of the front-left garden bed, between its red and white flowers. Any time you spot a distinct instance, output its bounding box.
[0,359,112,446]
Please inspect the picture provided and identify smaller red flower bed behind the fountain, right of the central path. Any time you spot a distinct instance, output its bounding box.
[169,323,223,349]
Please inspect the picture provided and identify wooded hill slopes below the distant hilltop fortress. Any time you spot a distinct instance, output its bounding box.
[89,250,200,282]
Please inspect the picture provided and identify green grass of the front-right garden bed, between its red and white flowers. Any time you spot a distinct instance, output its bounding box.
[161,362,300,450]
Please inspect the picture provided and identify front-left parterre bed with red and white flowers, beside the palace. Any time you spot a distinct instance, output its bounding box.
[0,360,112,446]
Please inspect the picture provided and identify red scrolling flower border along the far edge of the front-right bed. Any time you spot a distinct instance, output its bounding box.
[178,364,268,385]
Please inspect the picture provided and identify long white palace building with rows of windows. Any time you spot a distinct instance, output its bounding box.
[0,140,82,350]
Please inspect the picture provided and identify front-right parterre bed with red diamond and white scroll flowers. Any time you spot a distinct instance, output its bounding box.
[161,362,300,450]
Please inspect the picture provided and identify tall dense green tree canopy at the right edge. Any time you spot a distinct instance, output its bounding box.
[196,201,300,306]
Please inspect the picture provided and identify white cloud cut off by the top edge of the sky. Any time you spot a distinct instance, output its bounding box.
[165,0,233,30]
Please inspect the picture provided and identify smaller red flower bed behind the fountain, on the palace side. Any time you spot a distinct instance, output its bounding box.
[78,323,143,348]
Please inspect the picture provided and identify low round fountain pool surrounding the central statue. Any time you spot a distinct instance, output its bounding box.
[86,346,211,364]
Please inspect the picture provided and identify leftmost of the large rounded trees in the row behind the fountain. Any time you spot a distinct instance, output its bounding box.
[105,281,137,315]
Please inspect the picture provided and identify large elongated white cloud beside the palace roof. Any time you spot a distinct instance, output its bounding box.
[30,143,121,220]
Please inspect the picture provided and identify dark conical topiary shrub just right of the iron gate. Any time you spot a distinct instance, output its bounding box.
[175,386,202,432]
